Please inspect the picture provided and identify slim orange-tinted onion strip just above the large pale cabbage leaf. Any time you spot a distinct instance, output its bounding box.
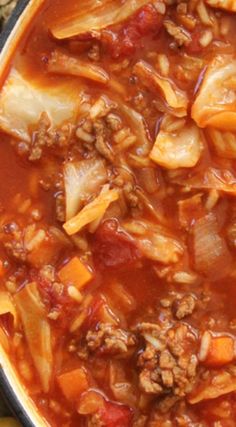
[48,50,109,83]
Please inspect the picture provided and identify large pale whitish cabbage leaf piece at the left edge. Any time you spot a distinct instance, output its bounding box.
[0,69,80,141]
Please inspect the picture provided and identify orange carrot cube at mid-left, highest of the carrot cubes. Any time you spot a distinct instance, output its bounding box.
[58,257,93,289]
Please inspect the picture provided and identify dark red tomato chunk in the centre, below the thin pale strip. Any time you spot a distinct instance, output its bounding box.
[93,219,141,268]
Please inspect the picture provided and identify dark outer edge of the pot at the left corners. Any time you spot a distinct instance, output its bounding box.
[0,0,35,427]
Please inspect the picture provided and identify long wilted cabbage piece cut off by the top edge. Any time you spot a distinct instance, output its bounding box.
[51,0,153,39]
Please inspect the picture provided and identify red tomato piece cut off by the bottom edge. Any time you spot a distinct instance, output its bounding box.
[99,402,133,427]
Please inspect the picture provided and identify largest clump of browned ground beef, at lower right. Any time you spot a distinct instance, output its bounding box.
[137,322,198,397]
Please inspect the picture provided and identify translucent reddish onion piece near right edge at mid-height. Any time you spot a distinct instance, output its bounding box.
[193,213,231,280]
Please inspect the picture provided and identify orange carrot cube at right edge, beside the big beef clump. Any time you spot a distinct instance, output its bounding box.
[204,336,234,367]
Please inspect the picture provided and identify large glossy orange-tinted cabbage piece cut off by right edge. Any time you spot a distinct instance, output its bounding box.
[192,55,236,131]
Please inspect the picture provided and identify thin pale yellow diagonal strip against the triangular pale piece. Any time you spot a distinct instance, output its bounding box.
[63,189,119,235]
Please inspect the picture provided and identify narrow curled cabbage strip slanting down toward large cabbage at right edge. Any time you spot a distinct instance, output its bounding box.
[133,60,188,117]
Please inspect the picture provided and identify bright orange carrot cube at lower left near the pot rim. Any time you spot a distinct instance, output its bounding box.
[57,367,89,401]
